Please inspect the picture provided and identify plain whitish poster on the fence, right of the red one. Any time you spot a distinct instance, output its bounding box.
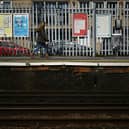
[96,14,112,37]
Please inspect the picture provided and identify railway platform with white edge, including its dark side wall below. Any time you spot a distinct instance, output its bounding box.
[0,56,129,93]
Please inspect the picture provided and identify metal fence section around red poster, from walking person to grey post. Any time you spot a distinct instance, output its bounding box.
[35,4,93,56]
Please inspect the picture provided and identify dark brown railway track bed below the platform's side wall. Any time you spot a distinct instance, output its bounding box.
[0,91,129,129]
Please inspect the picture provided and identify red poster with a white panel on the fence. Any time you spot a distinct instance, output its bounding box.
[72,13,88,37]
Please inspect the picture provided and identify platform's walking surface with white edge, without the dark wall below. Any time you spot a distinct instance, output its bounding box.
[0,56,129,67]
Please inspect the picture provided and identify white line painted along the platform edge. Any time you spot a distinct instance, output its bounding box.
[0,61,129,67]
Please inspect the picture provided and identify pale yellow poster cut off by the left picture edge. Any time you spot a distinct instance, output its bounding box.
[0,14,12,37]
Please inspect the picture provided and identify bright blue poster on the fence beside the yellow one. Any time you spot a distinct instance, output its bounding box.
[13,14,29,37]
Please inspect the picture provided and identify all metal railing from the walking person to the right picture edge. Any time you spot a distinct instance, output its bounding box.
[34,3,129,56]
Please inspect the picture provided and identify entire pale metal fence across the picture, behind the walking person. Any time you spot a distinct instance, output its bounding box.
[0,2,129,56]
